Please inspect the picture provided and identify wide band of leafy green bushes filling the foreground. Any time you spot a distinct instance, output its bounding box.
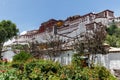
[0,59,117,80]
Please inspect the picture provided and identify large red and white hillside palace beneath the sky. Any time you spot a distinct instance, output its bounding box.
[14,10,116,43]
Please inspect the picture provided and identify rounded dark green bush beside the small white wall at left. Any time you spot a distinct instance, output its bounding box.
[13,51,32,62]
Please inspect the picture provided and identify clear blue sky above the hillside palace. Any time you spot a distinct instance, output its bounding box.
[0,0,120,32]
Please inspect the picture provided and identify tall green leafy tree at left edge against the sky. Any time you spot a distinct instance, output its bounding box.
[0,20,19,58]
